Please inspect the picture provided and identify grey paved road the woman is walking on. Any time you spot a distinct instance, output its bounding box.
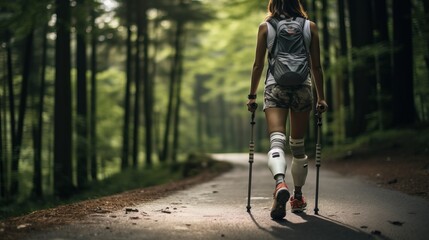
[22,154,429,240]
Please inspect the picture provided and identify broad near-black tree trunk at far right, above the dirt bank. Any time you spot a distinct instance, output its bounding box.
[391,0,416,127]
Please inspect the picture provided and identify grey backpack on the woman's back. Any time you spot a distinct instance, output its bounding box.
[268,17,310,86]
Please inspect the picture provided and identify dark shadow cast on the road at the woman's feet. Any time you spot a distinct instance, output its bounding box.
[249,213,382,240]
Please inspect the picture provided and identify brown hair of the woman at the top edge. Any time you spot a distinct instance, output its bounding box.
[267,0,308,19]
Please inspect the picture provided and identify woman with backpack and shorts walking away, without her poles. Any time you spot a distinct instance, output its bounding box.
[247,0,328,220]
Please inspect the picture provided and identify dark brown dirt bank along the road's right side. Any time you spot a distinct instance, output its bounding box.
[323,149,429,201]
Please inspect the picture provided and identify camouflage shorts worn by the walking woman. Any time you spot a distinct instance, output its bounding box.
[264,84,313,112]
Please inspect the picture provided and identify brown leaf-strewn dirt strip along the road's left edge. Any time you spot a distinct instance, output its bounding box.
[0,169,227,240]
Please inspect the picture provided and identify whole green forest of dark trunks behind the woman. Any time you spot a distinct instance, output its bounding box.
[0,0,429,206]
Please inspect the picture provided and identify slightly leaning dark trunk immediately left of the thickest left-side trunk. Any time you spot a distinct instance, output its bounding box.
[32,26,48,198]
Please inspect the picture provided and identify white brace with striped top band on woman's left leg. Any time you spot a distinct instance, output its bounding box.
[268,132,287,177]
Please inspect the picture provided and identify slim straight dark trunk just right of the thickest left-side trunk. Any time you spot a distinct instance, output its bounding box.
[76,0,88,189]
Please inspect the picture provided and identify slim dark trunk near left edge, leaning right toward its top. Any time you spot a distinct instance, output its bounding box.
[10,30,34,195]
